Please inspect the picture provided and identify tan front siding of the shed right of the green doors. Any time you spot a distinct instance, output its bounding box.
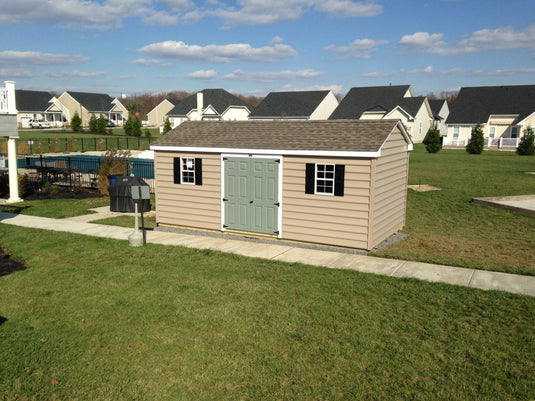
[282,157,370,248]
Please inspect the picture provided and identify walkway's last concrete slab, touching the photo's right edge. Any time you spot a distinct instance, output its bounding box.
[470,270,535,297]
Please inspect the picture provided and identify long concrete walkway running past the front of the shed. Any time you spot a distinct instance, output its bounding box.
[0,207,535,297]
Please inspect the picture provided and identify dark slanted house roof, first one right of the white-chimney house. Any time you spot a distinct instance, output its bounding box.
[249,90,329,118]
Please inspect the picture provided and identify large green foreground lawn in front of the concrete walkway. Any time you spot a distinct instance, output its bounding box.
[0,225,535,401]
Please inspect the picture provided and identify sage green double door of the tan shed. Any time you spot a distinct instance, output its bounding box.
[223,157,280,234]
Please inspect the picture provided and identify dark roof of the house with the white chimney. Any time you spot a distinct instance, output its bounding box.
[167,89,253,116]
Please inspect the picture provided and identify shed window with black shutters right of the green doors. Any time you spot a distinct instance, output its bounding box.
[305,163,345,196]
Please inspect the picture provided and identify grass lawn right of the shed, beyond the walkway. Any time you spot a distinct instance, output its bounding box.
[379,145,535,275]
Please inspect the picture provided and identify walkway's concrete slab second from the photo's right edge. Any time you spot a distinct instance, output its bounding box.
[392,262,473,286]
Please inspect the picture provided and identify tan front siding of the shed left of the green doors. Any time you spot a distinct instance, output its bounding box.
[154,152,221,230]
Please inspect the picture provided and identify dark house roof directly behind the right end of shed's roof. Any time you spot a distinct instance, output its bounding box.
[329,85,411,120]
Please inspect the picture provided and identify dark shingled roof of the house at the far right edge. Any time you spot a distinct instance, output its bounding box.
[446,85,535,124]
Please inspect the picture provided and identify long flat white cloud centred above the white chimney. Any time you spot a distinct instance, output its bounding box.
[138,40,297,63]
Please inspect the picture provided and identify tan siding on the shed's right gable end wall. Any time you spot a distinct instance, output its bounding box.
[368,129,409,248]
